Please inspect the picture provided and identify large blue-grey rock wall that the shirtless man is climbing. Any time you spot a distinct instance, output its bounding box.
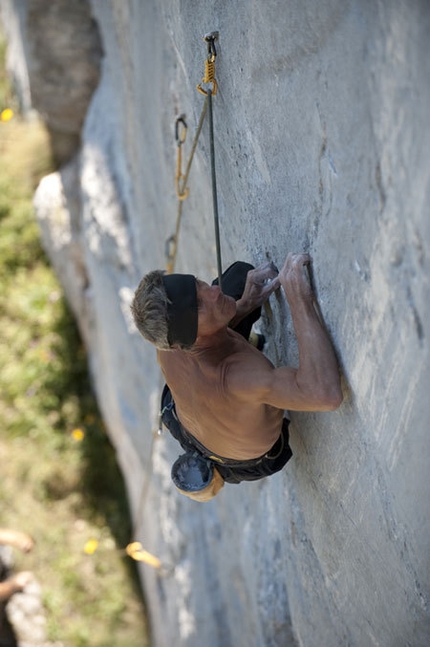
[2,0,430,647]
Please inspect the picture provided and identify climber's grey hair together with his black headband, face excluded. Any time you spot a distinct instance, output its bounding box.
[131,270,198,350]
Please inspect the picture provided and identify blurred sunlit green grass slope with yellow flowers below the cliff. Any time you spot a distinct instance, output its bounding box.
[0,29,148,647]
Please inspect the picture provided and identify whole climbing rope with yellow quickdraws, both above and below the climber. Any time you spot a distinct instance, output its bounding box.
[125,32,222,573]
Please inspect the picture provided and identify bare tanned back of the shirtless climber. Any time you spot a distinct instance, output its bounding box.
[158,329,283,460]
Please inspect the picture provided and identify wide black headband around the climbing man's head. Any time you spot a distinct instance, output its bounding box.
[163,274,198,348]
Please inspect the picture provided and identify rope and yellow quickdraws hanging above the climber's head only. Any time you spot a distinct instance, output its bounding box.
[166,31,222,289]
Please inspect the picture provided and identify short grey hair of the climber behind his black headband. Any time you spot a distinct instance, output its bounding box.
[130,270,171,350]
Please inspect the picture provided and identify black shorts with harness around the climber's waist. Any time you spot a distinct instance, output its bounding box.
[161,385,293,483]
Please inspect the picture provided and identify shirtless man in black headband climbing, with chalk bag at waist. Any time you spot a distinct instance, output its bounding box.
[131,254,342,501]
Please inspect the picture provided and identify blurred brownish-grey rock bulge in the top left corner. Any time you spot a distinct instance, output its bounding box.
[3,0,102,163]
